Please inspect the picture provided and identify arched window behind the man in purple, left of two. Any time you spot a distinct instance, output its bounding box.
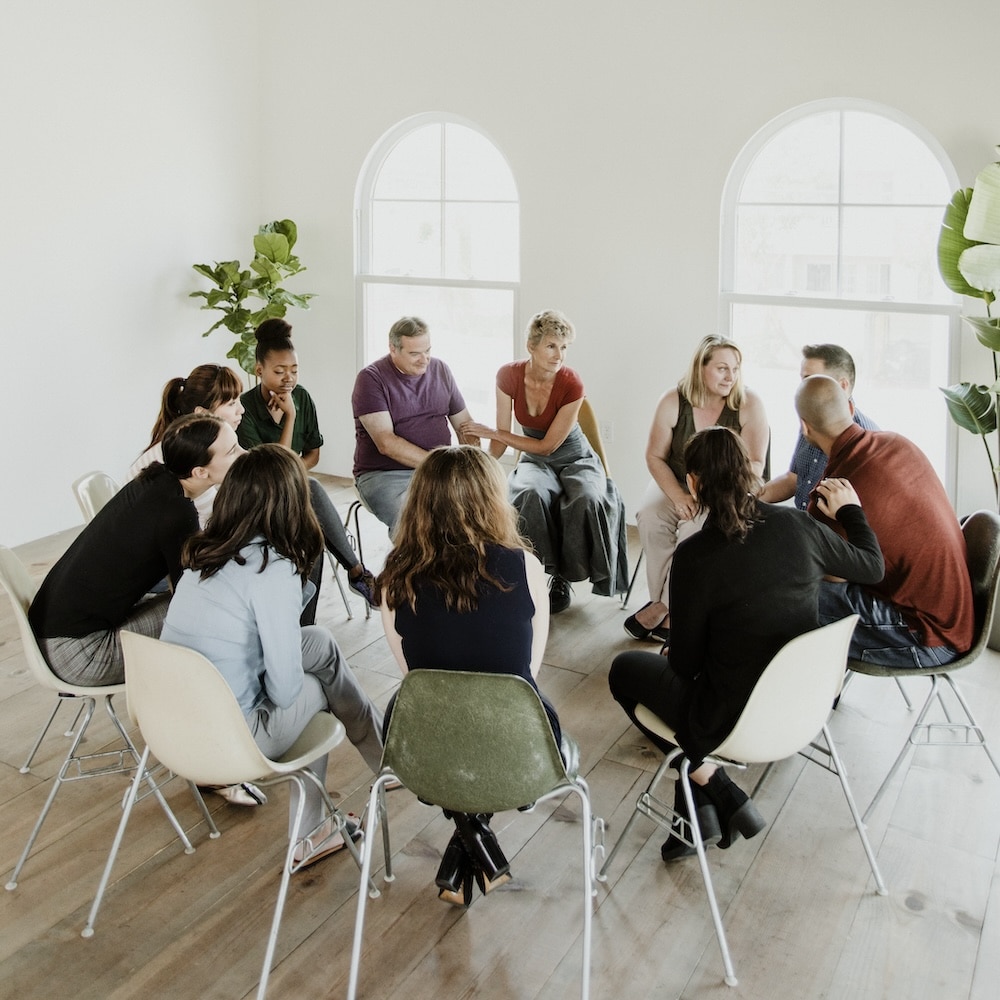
[355,114,519,422]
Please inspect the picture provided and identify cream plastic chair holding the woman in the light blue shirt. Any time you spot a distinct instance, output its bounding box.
[81,631,374,998]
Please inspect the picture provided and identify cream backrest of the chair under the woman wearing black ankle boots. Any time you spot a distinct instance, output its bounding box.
[713,615,858,764]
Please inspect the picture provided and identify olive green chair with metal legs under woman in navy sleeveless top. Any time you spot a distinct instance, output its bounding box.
[347,670,604,1000]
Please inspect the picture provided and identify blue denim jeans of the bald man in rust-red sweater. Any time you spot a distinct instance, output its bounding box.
[819,581,960,667]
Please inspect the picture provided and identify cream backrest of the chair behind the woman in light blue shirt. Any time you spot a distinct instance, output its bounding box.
[120,630,286,785]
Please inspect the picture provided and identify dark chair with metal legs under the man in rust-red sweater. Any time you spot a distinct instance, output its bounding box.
[847,510,1000,819]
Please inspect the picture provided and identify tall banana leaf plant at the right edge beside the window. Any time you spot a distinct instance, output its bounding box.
[938,146,1000,503]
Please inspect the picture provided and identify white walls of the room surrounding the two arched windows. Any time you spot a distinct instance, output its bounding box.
[0,0,1000,544]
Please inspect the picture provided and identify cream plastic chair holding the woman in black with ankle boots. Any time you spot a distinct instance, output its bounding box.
[598,615,888,986]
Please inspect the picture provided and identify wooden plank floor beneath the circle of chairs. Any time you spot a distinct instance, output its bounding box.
[0,477,1000,1000]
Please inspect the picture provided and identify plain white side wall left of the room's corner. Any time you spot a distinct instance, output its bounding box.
[0,0,263,545]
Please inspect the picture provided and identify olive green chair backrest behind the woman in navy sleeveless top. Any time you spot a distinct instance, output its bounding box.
[382,670,567,813]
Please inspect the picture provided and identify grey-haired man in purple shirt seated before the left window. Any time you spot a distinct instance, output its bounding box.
[351,316,479,534]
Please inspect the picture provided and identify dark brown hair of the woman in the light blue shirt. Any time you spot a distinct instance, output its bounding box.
[182,444,323,581]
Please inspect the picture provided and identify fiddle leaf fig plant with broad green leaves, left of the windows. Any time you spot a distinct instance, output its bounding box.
[191,219,314,375]
